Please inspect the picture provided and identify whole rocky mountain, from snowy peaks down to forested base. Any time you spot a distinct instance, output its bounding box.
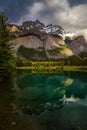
[10,20,87,60]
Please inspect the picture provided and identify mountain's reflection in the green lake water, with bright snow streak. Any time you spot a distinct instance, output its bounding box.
[15,73,87,115]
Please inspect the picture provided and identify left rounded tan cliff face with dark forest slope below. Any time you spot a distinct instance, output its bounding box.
[13,36,46,60]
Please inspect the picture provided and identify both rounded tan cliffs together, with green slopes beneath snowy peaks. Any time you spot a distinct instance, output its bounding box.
[13,35,73,60]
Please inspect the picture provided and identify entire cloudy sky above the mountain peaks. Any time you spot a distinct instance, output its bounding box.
[0,0,87,32]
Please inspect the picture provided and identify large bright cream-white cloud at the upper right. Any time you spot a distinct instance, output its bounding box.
[46,0,87,31]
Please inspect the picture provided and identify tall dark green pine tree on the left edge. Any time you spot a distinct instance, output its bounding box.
[0,12,16,76]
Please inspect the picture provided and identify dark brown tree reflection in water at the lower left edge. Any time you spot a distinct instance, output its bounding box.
[0,77,17,130]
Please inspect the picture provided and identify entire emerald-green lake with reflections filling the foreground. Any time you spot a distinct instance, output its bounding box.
[0,71,87,130]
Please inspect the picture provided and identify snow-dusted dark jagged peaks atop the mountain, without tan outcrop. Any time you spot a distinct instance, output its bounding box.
[22,20,65,37]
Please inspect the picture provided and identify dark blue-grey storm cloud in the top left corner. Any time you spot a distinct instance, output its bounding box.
[0,0,41,22]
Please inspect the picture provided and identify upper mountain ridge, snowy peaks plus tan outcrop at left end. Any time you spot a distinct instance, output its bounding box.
[10,20,65,38]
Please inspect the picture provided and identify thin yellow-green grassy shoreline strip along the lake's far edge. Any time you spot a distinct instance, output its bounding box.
[16,66,87,73]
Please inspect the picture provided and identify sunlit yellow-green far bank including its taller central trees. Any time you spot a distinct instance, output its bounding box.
[17,62,87,73]
